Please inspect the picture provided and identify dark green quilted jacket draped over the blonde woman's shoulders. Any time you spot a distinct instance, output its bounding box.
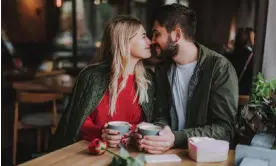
[50,63,155,151]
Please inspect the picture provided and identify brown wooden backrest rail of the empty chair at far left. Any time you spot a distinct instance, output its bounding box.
[16,92,63,103]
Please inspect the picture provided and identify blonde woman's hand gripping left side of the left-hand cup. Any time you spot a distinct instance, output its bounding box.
[102,123,122,148]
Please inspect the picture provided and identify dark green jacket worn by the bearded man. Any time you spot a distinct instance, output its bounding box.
[155,43,238,147]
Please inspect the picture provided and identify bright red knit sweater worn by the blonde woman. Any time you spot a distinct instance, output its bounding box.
[80,75,143,141]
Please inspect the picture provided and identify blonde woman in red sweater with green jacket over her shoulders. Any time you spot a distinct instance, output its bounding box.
[50,16,157,149]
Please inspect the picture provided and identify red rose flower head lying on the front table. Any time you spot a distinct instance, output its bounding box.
[88,138,107,155]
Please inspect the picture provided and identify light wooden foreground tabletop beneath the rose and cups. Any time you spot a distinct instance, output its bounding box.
[21,141,234,166]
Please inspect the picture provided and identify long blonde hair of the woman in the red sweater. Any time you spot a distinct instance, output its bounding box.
[93,16,150,116]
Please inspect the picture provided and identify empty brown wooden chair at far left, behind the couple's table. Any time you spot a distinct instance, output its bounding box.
[13,92,63,165]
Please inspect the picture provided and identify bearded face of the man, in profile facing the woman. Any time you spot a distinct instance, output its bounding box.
[151,21,179,60]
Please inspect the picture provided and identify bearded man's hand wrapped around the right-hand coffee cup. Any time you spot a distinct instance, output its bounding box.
[139,126,175,154]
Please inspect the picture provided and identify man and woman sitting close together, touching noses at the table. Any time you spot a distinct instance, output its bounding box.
[50,4,238,154]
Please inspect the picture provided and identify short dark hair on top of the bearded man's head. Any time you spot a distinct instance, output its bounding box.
[152,3,196,40]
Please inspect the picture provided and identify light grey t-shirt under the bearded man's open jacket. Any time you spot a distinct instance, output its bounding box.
[168,61,197,130]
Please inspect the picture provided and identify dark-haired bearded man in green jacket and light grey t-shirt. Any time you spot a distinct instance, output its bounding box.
[135,4,238,153]
